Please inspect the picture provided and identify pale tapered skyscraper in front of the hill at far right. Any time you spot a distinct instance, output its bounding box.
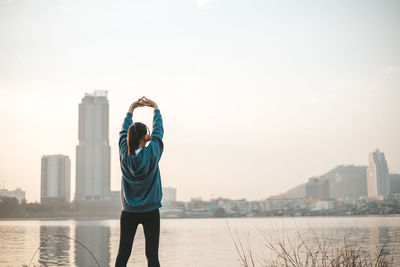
[367,149,390,199]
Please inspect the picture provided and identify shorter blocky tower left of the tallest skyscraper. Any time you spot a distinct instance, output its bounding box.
[40,155,71,203]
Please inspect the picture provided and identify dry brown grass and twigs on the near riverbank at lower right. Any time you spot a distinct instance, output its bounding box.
[228,226,399,267]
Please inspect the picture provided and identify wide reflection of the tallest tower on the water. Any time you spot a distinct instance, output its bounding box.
[75,224,110,267]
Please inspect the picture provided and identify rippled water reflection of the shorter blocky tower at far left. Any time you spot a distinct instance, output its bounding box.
[39,226,71,267]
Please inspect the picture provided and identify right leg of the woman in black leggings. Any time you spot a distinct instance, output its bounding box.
[142,209,160,267]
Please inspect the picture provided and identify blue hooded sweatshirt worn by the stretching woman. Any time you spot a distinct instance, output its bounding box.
[119,109,164,212]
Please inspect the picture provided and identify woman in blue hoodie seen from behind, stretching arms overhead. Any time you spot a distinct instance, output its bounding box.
[115,97,164,267]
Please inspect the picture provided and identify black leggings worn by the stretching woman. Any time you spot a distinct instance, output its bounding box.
[115,209,160,267]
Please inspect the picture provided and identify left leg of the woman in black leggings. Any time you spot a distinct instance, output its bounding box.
[115,211,138,267]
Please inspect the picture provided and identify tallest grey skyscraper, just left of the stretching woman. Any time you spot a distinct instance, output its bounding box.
[75,90,111,200]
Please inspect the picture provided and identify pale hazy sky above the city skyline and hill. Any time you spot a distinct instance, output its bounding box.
[0,0,400,201]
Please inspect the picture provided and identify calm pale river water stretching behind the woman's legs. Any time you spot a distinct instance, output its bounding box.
[0,216,400,267]
